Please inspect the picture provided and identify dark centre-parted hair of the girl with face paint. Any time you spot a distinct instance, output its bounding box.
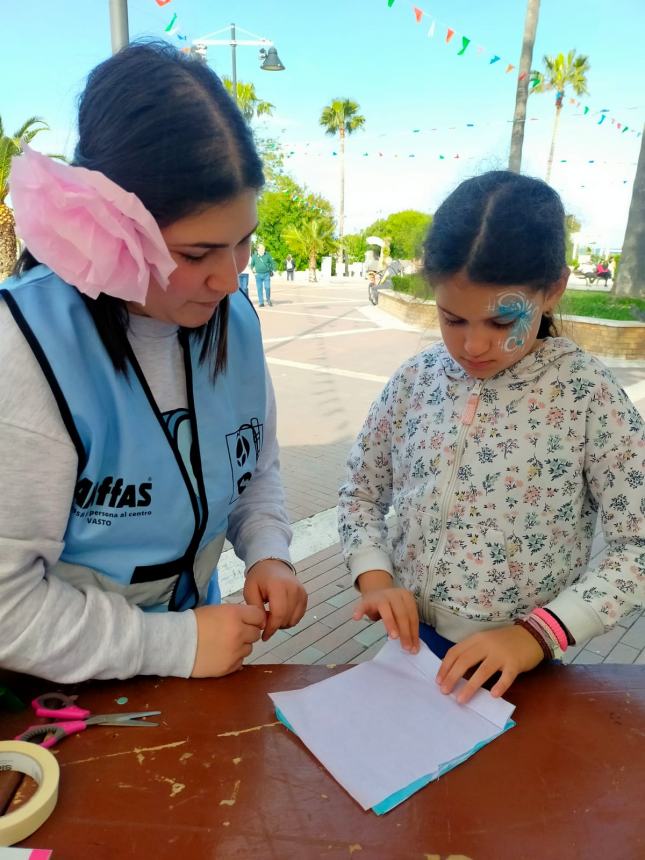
[424,170,566,338]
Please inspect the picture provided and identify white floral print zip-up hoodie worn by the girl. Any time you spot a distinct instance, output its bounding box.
[339,338,645,644]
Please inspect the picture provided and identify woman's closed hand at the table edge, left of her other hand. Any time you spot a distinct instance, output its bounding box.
[191,603,266,678]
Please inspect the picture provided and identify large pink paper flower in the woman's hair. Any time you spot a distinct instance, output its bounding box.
[9,144,177,304]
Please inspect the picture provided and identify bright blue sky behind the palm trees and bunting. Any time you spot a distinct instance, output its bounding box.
[5,0,645,247]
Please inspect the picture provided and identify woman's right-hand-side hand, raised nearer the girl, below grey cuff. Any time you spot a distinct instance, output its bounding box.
[244,558,307,642]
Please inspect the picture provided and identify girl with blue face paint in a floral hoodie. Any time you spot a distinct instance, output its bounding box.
[339,171,645,702]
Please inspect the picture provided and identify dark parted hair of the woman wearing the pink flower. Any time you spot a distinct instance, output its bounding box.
[15,42,264,374]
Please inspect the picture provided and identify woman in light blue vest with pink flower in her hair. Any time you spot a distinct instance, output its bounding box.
[0,44,306,682]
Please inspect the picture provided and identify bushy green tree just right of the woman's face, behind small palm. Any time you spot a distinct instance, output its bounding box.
[258,174,335,268]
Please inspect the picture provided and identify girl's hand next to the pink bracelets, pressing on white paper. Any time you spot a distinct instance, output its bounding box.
[436,624,544,704]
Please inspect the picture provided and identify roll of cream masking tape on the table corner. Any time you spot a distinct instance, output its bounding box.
[0,741,60,845]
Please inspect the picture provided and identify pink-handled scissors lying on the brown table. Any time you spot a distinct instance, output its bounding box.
[15,693,161,748]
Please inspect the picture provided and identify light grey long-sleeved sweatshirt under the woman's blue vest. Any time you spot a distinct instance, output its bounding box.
[0,302,291,683]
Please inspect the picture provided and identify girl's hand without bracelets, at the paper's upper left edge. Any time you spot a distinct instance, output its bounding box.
[352,570,419,654]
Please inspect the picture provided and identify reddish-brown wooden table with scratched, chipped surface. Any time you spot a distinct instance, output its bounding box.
[0,665,645,860]
